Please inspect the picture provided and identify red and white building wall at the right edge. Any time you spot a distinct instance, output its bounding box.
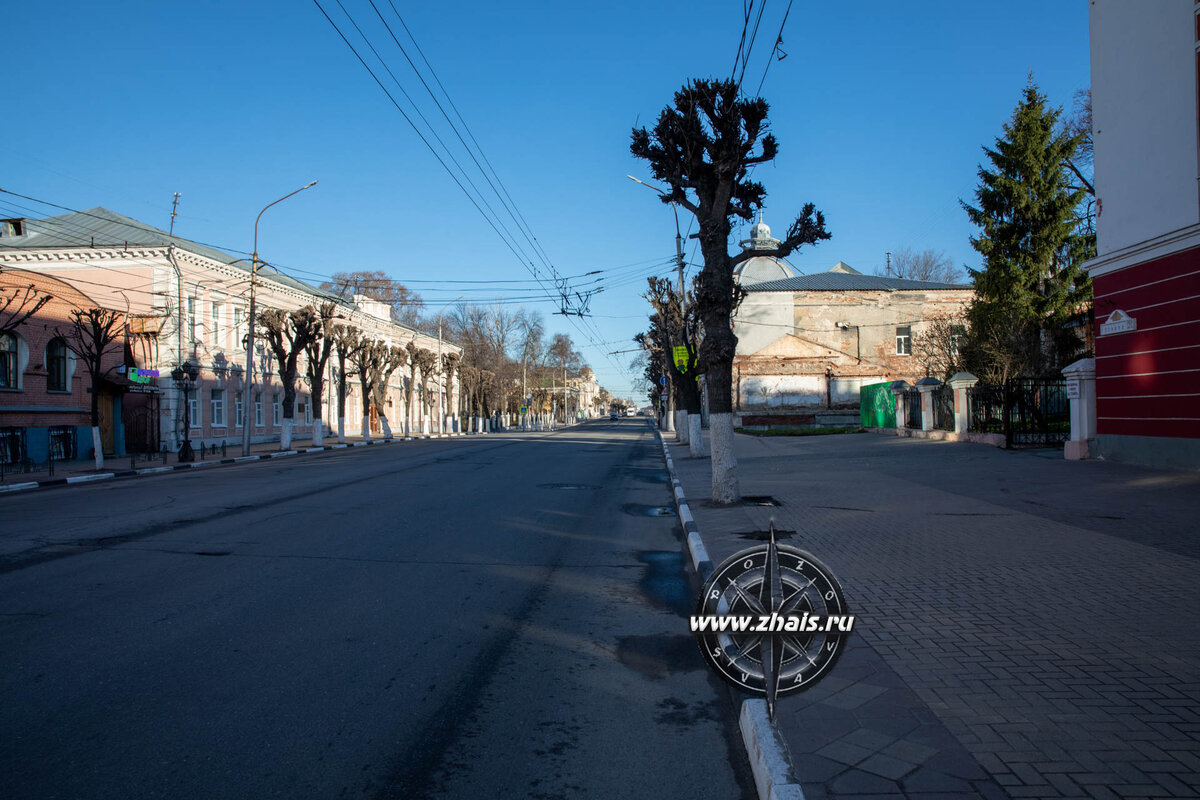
[1087,0,1200,469]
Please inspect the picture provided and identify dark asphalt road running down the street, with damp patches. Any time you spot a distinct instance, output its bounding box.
[0,420,754,800]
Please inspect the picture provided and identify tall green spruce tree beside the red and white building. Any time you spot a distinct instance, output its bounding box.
[962,76,1094,379]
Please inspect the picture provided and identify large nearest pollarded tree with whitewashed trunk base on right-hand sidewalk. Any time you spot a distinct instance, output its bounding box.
[630,80,829,503]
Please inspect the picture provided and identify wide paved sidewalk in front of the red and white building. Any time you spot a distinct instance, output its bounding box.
[668,434,1200,800]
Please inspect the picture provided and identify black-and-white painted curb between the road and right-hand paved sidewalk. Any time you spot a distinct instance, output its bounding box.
[654,431,804,800]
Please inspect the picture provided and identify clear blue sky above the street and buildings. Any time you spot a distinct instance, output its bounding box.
[0,0,1090,393]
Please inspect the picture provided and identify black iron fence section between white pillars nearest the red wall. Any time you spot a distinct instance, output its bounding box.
[967,378,1070,447]
